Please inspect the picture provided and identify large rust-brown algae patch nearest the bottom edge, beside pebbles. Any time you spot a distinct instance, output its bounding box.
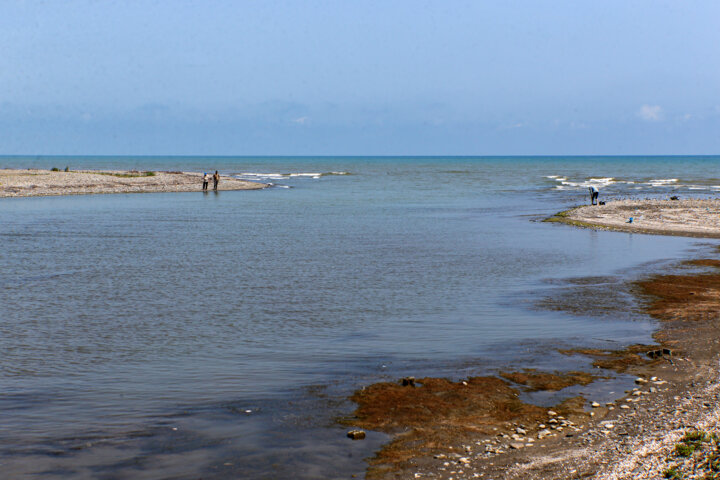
[345,377,589,478]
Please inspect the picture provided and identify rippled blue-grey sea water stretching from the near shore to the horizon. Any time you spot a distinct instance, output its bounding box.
[0,156,720,479]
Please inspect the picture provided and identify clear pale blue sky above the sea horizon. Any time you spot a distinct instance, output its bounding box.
[0,0,720,155]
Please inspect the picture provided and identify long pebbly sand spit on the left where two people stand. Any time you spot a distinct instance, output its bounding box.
[0,169,268,197]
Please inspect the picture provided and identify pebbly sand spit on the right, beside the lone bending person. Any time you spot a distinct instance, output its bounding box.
[546,199,720,238]
